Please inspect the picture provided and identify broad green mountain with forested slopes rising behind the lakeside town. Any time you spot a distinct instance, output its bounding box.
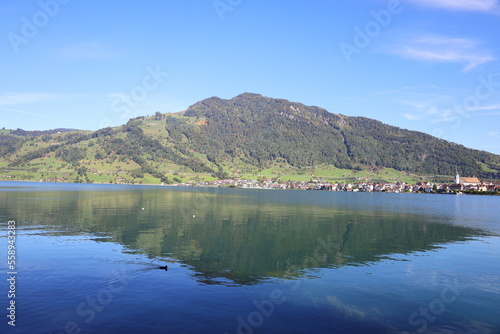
[0,93,500,182]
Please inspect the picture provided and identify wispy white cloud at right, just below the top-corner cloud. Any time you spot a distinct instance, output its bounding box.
[389,35,496,72]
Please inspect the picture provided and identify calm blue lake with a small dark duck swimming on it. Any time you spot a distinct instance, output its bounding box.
[0,182,500,334]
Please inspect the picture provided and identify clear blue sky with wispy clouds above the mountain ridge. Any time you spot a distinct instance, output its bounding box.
[0,0,500,154]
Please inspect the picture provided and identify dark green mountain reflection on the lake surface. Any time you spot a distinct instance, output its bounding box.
[0,188,487,284]
